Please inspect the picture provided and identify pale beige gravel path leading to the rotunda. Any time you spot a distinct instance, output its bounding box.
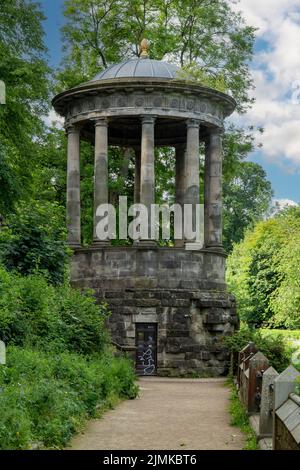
[71,377,245,450]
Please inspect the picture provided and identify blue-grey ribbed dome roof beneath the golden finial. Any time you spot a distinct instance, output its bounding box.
[92,57,180,81]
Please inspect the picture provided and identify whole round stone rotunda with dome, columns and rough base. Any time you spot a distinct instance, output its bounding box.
[53,41,238,375]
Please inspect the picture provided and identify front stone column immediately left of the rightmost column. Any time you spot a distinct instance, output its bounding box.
[184,119,200,246]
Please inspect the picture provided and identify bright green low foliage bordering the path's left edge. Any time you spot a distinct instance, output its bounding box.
[0,346,137,449]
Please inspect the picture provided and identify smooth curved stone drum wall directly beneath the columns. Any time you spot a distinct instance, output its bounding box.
[71,247,227,290]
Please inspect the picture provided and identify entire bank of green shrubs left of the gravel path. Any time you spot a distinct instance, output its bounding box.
[0,258,137,449]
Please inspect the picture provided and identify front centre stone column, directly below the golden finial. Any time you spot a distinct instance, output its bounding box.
[140,116,155,244]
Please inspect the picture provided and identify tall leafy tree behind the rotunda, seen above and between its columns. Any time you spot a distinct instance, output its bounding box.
[57,0,268,249]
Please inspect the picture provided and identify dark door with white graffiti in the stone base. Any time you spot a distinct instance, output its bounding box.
[136,323,157,375]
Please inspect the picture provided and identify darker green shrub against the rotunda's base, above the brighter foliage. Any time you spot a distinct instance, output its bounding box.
[0,268,109,354]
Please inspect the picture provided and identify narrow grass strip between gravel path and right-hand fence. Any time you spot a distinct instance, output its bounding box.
[227,380,258,450]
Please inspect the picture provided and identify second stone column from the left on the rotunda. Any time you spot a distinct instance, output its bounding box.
[93,118,109,245]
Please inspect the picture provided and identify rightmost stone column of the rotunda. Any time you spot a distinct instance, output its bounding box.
[204,128,223,250]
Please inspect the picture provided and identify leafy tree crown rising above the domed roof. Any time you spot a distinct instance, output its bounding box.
[59,0,255,110]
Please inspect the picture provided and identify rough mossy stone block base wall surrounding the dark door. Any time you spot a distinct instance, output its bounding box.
[104,289,236,375]
